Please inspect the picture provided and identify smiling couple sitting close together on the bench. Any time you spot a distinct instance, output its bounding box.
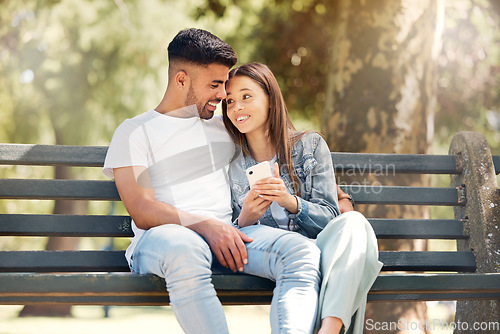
[104,29,382,334]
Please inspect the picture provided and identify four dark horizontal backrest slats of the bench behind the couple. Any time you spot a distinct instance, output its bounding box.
[0,144,500,272]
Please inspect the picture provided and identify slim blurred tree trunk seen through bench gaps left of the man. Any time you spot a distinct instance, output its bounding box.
[19,166,88,317]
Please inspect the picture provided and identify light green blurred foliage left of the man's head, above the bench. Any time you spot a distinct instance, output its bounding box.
[0,0,230,145]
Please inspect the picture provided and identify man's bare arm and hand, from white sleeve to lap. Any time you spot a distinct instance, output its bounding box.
[113,166,252,271]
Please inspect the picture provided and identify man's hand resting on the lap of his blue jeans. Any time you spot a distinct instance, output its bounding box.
[186,219,253,272]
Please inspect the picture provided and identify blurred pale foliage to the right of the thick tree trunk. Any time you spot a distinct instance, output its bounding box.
[436,0,500,154]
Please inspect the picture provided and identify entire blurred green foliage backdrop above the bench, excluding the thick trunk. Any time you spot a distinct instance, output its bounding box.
[0,0,500,147]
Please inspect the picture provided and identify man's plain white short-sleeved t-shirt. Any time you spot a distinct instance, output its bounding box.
[103,110,235,263]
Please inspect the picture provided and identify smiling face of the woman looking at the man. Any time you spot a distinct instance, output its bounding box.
[226,75,269,135]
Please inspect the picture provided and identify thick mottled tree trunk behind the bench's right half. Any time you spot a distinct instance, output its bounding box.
[322,0,443,333]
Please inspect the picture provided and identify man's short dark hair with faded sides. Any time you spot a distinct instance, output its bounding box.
[167,28,238,68]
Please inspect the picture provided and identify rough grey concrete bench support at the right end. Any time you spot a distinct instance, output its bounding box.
[449,132,500,333]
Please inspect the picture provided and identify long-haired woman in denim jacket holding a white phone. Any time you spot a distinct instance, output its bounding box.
[222,63,382,334]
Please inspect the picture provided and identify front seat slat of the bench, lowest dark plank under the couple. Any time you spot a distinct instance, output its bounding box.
[0,273,500,305]
